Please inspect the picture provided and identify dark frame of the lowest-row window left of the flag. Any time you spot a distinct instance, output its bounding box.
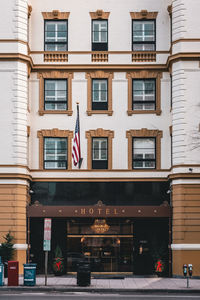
[43,137,68,170]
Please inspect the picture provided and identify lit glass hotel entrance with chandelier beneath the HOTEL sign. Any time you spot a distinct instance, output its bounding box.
[67,219,134,273]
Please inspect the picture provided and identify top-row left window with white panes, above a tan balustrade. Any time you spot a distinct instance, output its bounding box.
[44,20,68,51]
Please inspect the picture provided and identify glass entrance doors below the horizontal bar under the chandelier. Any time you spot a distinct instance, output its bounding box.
[67,235,133,273]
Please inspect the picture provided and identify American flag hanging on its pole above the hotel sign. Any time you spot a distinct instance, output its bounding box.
[72,104,82,169]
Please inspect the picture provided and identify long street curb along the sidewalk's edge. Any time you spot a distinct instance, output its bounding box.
[0,286,200,294]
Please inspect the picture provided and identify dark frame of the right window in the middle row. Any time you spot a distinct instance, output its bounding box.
[132,78,156,111]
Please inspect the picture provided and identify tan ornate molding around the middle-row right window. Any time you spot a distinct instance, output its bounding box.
[126,70,162,116]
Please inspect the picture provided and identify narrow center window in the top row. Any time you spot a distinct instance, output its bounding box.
[92,20,108,51]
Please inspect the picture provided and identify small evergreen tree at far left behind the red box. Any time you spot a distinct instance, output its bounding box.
[0,231,14,277]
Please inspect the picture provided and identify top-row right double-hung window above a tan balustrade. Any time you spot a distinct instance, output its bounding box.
[132,20,156,51]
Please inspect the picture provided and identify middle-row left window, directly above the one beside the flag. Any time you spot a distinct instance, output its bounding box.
[44,79,67,110]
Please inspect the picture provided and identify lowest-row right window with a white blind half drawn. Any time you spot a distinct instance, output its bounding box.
[133,138,156,169]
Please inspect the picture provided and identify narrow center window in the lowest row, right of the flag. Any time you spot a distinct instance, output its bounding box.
[92,138,108,169]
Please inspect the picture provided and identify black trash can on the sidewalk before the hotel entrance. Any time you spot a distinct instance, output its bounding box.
[77,262,91,286]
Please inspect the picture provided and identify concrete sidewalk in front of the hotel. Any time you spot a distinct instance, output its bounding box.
[0,276,200,294]
